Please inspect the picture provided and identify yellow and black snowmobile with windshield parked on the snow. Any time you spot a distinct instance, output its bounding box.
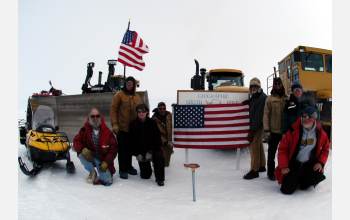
[18,105,75,176]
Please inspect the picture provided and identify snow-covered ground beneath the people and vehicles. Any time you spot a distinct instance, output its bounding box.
[18,146,332,220]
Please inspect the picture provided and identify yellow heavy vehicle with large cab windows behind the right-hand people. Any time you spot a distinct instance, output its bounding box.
[267,46,332,136]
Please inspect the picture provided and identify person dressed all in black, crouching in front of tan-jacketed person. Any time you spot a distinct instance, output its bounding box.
[130,104,164,186]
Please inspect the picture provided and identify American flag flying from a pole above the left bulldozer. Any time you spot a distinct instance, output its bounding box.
[118,30,149,71]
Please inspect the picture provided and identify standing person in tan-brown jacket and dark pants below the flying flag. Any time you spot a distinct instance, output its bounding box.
[110,76,142,179]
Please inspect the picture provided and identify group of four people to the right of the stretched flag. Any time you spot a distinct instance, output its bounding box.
[243,77,330,194]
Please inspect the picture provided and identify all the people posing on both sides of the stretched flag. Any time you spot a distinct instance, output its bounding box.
[73,77,329,194]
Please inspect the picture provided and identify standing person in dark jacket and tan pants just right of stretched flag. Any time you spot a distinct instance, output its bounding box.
[243,77,266,180]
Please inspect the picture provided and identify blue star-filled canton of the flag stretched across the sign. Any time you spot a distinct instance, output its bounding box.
[174,105,204,128]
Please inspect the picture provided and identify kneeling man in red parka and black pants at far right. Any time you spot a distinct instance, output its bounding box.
[275,105,329,194]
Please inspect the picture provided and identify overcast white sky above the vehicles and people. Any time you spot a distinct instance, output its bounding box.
[18,0,332,115]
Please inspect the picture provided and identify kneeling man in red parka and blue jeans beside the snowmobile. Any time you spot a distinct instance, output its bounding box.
[73,108,117,186]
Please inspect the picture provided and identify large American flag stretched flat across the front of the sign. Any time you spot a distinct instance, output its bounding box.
[174,104,249,149]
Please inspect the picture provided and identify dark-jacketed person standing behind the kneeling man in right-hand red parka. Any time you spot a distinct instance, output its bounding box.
[282,80,303,133]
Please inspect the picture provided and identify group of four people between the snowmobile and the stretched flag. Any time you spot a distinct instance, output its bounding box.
[73,77,173,186]
